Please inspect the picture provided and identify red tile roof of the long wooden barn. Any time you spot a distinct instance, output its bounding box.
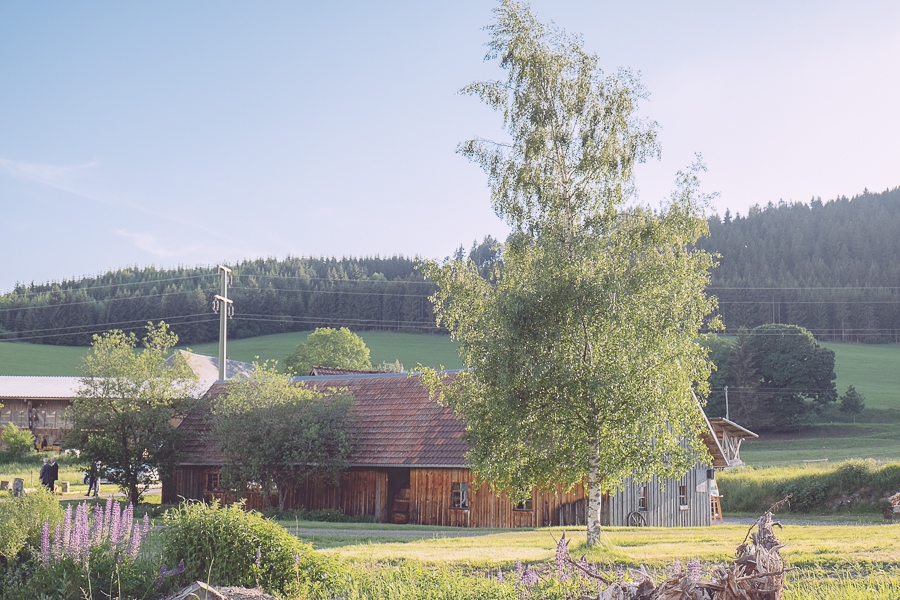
[179,373,468,467]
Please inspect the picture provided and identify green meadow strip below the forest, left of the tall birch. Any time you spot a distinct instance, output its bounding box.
[0,331,461,376]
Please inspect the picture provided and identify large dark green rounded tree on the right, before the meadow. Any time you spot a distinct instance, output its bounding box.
[746,324,837,431]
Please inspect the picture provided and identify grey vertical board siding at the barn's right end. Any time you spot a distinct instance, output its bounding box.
[602,466,712,527]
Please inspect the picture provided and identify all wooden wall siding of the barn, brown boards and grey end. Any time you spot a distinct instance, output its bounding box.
[163,466,711,528]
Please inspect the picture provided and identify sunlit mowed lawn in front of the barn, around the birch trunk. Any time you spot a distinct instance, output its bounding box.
[282,515,900,569]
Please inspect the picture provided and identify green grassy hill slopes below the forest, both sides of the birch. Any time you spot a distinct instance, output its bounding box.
[0,331,900,465]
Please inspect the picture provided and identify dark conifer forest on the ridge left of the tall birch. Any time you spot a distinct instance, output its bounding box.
[0,256,437,345]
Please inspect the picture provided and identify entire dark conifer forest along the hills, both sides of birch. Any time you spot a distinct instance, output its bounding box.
[0,188,900,345]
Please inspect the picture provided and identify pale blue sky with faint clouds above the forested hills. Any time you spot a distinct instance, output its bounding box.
[0,0,900,291]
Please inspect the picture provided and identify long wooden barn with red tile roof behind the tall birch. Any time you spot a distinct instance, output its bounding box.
[163,373,753,528]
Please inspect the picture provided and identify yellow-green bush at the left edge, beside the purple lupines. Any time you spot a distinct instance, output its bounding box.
[0,486,63,564]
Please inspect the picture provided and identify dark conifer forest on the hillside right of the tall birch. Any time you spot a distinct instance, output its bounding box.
[701,188,900,343]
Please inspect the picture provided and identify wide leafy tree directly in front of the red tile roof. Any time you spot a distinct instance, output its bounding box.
[211,364,353,510]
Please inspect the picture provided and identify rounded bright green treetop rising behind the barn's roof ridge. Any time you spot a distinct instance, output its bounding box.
[284,327,372,375]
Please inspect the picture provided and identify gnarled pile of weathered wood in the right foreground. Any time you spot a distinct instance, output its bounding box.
[569,496,792,600]
